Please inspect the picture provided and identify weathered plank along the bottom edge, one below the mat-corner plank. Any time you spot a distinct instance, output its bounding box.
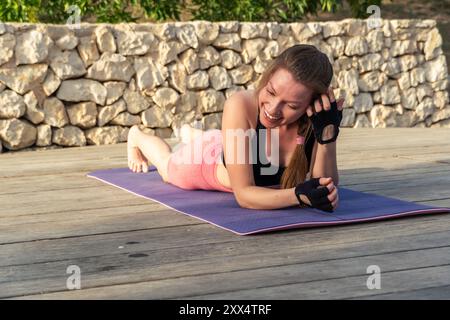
[6,235,450,299]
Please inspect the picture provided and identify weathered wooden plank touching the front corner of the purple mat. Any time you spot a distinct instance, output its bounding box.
[0,215,450,296]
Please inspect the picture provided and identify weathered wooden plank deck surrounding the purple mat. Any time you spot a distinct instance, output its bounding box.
[0,128,450,299]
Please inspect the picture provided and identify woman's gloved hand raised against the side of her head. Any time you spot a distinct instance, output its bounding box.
[306,87,344,144]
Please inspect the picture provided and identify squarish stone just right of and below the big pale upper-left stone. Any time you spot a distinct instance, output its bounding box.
[50,51,86,80]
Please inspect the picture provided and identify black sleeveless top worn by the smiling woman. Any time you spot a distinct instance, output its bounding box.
[222,110,314,186]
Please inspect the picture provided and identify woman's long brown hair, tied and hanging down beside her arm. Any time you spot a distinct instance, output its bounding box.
[255,44,333,189]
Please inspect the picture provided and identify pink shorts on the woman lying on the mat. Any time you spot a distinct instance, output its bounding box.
[168,129,233,192]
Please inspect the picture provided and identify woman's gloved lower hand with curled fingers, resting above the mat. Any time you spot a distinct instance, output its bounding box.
[295,177,339,212]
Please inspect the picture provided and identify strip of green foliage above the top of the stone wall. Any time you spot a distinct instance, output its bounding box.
[0,0,381,23]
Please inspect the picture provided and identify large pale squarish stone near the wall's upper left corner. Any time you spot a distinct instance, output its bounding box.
[15,30,52,65]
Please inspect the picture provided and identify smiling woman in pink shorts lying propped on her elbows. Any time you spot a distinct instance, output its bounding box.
[128,45,343,212]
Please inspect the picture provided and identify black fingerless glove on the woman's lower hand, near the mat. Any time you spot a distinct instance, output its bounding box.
[295,178,333,212]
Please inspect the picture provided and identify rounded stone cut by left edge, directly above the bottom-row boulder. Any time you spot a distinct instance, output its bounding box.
[0,119,37,150]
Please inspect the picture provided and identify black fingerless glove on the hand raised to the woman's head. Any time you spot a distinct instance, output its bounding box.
[310,101,342,144]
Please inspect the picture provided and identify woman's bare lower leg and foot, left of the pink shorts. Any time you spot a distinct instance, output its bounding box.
[127,126,172,182]
